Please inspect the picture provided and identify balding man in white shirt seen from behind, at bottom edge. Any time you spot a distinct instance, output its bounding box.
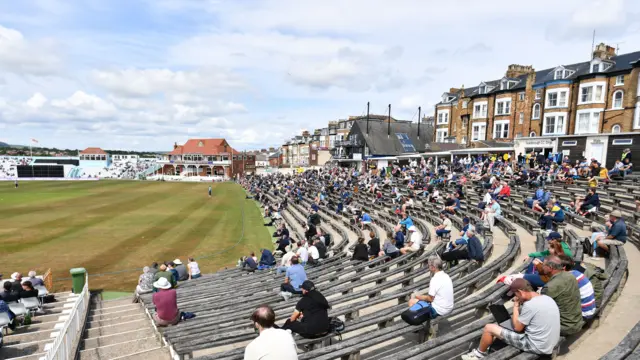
[244,305,298,360]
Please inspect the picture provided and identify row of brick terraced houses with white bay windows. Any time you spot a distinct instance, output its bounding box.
[434,44,640,147]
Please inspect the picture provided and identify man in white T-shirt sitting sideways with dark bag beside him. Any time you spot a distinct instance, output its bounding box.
[409,256,454,319]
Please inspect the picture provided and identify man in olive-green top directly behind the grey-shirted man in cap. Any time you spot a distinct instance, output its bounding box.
[541,256,584,336]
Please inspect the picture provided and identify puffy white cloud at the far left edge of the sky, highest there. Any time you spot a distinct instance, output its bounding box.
[0,25,62,75]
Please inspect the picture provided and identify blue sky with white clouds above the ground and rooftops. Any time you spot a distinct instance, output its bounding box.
[0,0,640,151]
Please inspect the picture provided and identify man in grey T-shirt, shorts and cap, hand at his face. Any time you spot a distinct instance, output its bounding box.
[462,279,560,360]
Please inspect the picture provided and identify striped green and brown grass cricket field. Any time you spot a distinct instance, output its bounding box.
[0,181,270,291]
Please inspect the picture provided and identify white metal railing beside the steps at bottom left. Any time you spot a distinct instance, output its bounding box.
[45,275,90,360]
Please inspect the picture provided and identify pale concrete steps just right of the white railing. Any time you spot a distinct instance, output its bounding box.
[77,297,171,360]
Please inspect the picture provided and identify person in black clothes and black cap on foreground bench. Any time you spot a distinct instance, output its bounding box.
[282,280,331,338]
